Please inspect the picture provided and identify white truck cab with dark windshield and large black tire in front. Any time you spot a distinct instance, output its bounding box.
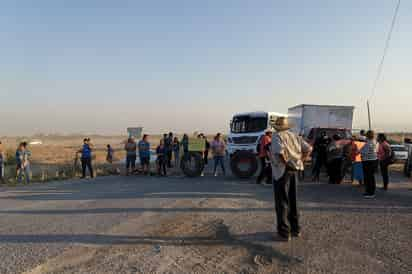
[227,111,287,178]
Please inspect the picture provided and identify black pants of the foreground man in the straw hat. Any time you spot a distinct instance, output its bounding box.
[273,171,300,236]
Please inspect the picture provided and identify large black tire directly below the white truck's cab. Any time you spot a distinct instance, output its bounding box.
[230,151,259,179]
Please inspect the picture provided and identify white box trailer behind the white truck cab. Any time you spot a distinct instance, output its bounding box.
[288,105,355,137]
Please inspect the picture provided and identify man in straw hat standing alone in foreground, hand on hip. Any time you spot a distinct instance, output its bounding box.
[269,117,312,241]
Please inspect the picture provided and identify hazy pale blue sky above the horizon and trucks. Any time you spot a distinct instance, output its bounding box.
[0,0,412,135]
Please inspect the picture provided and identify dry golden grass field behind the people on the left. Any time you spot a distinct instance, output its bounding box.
[0,135,217,183]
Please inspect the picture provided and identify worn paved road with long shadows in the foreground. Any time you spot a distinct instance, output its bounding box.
[0,174,412,273]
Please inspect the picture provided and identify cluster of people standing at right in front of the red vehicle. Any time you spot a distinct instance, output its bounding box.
[312,130,394,198]
